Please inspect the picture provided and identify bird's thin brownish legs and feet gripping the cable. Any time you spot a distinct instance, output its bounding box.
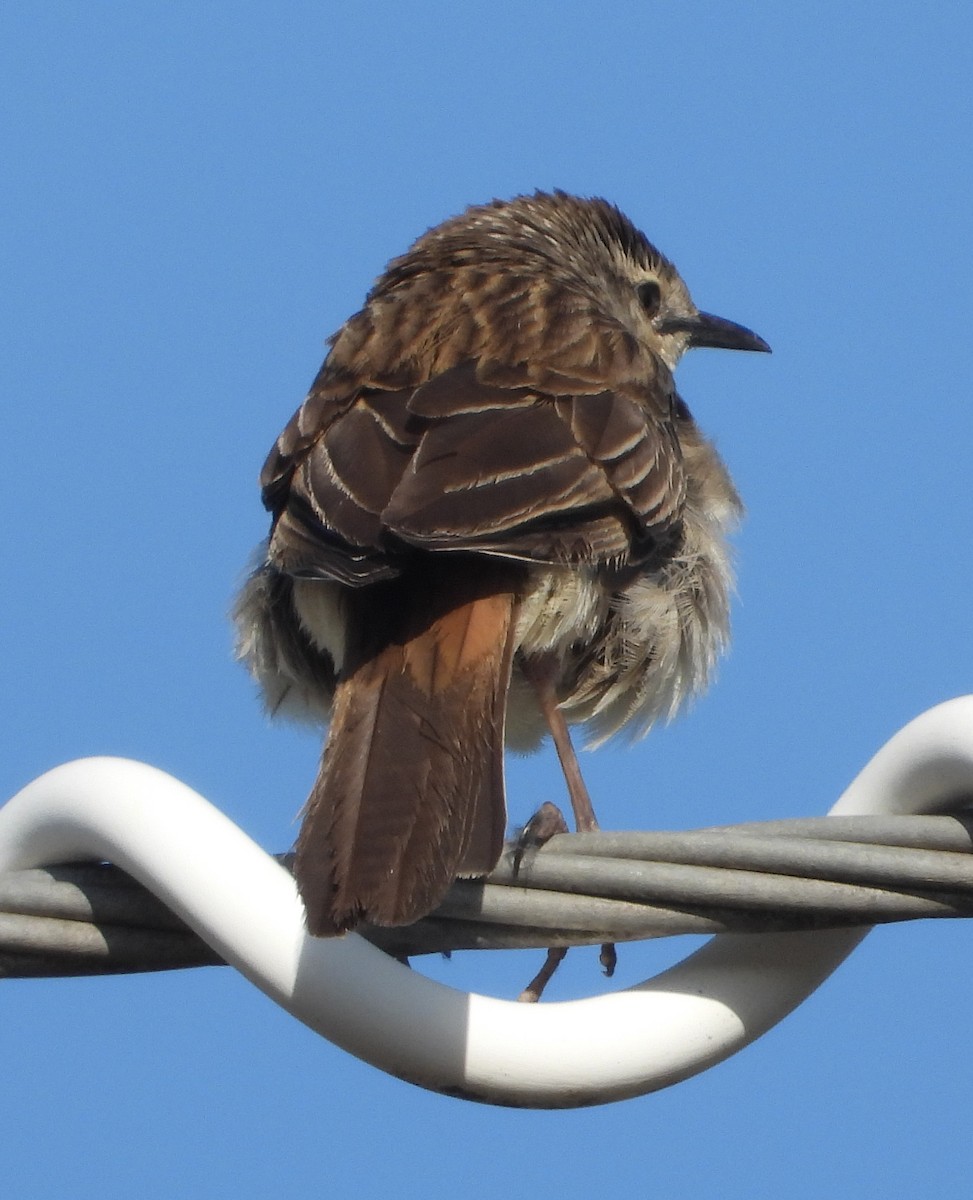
[518,654,618,1002]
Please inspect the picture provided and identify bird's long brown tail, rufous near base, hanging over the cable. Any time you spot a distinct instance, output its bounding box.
[295,558,518,936]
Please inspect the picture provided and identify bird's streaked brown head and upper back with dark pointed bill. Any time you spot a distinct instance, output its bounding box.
[333,191,770,378]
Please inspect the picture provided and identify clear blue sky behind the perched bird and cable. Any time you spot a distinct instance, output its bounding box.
[0,0,973,1200]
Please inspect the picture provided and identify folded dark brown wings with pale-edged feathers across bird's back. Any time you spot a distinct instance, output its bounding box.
[263,364,685,584]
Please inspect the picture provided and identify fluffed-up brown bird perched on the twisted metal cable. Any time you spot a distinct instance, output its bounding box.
[234,191,769,937]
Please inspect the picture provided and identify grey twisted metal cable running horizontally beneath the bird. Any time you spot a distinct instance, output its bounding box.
[0,814,973,978]
